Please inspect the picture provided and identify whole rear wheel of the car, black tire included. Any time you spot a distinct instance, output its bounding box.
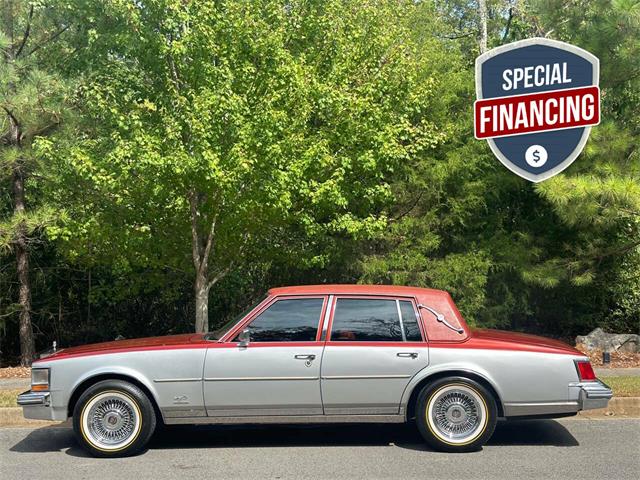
[416,377,498,452]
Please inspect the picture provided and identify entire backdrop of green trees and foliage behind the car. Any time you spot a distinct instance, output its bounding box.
[0,0,640,357]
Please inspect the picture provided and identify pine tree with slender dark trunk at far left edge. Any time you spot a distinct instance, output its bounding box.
[0,0,69,365]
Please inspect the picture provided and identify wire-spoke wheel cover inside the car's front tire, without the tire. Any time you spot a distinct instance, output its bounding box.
[81,391,142,451]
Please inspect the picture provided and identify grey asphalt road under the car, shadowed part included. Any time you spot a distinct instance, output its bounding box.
[0,419,640,480]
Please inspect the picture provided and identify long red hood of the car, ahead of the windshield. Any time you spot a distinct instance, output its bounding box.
[34,333,207,361]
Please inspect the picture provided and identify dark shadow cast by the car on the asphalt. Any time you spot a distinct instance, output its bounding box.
[11,420,579,457]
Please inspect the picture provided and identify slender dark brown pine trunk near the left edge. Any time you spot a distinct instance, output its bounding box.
[13,165,35,366]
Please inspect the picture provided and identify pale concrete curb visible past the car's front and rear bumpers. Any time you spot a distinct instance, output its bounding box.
[0,397,640,428]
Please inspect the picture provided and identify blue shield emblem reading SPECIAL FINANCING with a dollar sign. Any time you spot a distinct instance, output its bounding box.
[475,38,600,182]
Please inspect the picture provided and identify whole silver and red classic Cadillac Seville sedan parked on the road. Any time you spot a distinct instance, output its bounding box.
[18,285,612,457]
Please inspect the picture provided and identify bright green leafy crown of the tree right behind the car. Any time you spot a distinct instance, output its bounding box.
[39,0,460,330]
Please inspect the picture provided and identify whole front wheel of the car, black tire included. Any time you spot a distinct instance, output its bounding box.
[73,380,156,457]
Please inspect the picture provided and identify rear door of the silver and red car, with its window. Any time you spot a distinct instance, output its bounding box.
[321,296,429,415]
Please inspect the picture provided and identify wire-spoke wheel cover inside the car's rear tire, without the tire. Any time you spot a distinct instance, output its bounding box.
[425,384,488,445]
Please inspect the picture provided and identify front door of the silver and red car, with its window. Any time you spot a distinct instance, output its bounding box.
[204,296,326,416]
